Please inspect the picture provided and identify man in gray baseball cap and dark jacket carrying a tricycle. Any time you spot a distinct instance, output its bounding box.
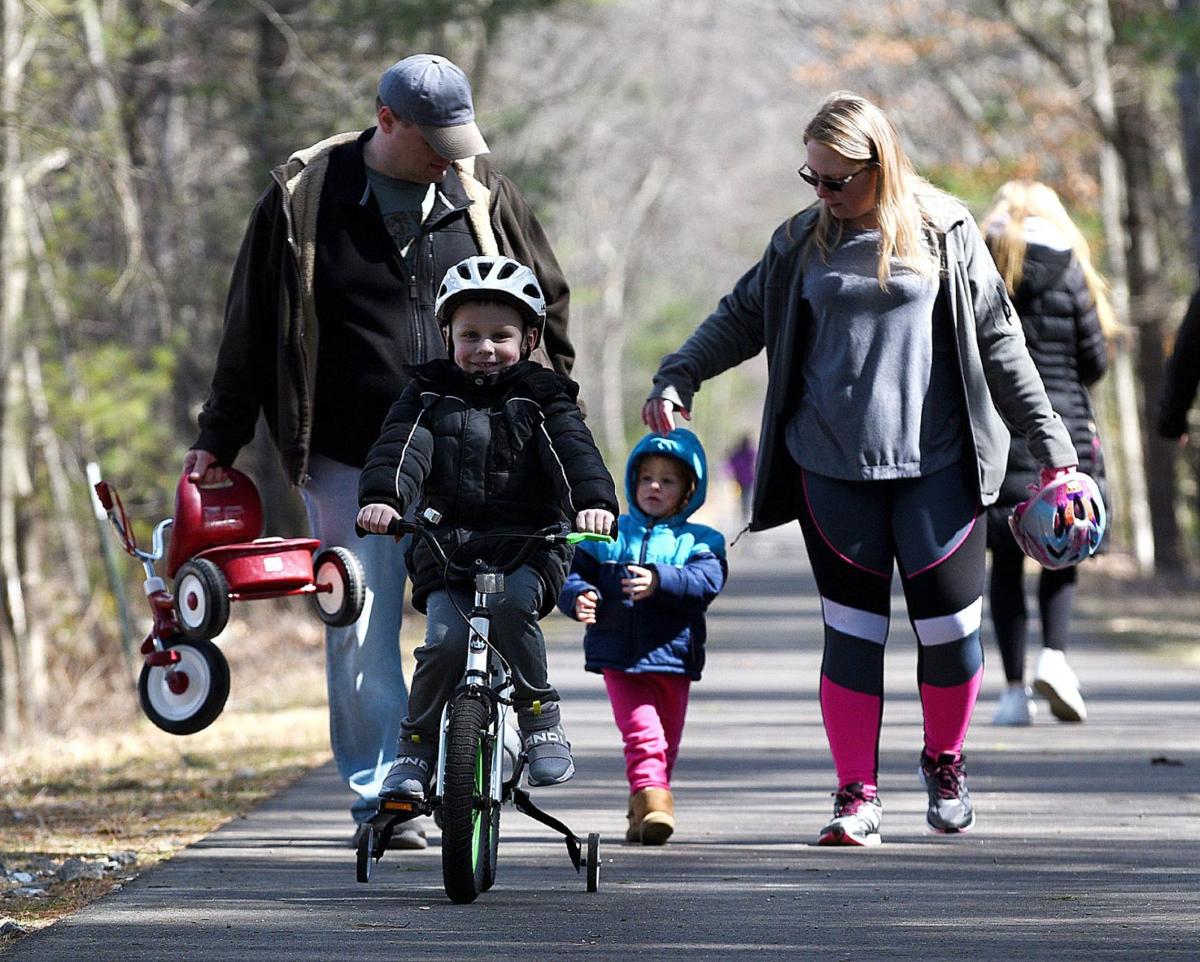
[184,54,575,848]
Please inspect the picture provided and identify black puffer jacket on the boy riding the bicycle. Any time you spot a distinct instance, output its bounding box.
[359,359,618,615]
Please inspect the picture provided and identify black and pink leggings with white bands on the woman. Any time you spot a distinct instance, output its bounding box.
[800,465,986,787]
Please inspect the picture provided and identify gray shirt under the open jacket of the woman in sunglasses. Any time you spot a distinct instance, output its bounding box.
[787,230,964,481]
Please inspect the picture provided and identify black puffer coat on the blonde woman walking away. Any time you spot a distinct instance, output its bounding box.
[990,243,1108,534]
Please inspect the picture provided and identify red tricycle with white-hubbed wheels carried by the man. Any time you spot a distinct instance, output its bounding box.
[96,468,366,735]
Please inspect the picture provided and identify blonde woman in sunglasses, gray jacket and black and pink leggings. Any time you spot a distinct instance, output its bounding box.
[642,92,1075,844]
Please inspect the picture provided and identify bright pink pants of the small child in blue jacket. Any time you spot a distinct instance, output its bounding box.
[604,668,691,794]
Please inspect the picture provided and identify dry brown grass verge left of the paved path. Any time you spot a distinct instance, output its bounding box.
[0,605,329,930]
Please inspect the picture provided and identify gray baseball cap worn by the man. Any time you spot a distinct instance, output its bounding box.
[379,54,491,161]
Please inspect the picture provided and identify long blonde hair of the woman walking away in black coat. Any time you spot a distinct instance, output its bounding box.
[979,180,1118,337]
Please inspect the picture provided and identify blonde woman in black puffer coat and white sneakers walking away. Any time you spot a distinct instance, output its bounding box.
[980,180,1116,724]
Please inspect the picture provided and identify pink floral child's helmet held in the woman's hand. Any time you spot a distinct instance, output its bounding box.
[1008,471,1108,571]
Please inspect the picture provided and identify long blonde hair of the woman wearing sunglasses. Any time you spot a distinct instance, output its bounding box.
[804,90,940,290]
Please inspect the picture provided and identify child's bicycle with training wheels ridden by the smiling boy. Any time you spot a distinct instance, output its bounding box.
[358,509,608,903]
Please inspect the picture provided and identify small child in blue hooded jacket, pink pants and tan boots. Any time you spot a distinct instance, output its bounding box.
[558,428,727,846]
